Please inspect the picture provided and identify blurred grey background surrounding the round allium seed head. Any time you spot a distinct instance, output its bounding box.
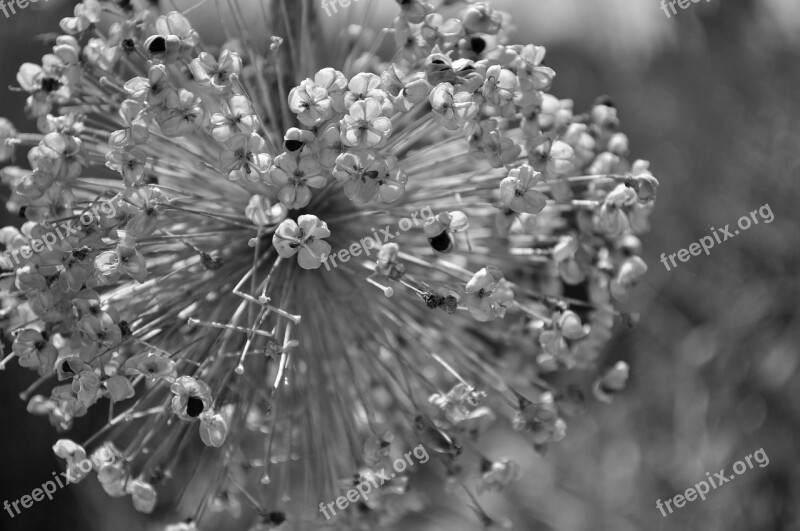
[0,0,800,531]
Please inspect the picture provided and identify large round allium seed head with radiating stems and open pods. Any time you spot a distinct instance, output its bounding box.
[0,0,658,530]
